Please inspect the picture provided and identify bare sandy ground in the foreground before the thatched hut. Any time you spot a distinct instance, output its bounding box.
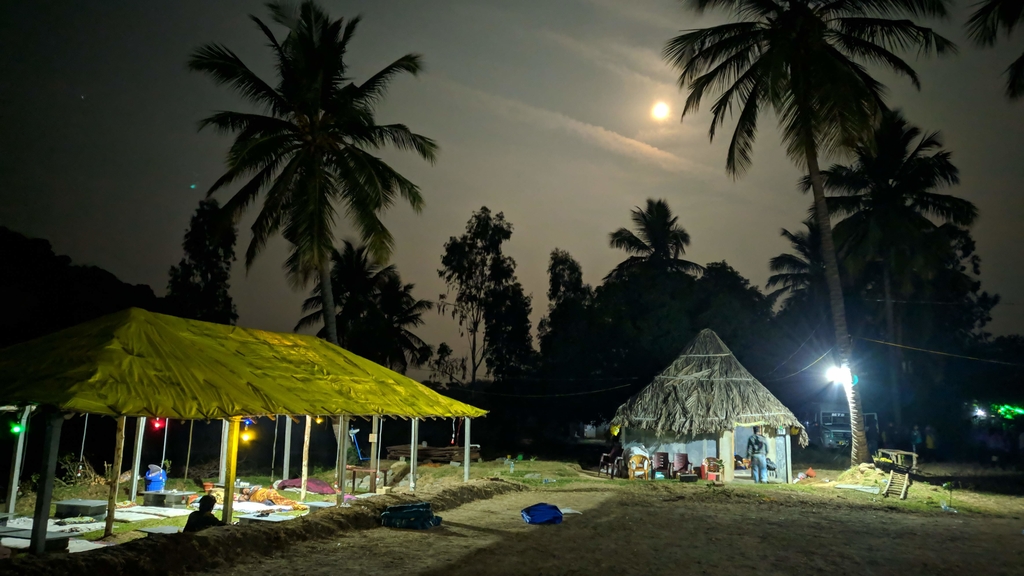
[195,485,1024,576]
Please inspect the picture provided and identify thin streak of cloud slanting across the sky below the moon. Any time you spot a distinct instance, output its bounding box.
[433,78,703,172]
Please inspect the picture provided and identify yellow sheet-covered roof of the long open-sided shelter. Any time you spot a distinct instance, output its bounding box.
[0,308,486,419]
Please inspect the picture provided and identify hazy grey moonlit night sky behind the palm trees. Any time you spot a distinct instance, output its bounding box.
[0,0,1024,373]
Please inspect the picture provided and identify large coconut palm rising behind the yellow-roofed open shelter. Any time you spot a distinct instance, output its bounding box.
[188,1,437,343]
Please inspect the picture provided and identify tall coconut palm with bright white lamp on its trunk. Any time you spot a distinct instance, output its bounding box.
[665,0,955,463]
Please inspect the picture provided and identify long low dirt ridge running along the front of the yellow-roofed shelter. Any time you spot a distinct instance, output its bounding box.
[0,480,526,576]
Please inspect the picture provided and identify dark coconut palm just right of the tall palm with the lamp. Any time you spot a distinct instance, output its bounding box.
[804,111,978,424]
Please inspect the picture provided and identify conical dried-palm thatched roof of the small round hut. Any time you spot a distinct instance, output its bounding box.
[611,330,807,446]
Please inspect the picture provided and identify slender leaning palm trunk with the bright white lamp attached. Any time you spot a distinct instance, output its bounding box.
[807,149,868,466]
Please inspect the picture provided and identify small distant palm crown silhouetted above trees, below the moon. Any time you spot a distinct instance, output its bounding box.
[605,199,703,280]
